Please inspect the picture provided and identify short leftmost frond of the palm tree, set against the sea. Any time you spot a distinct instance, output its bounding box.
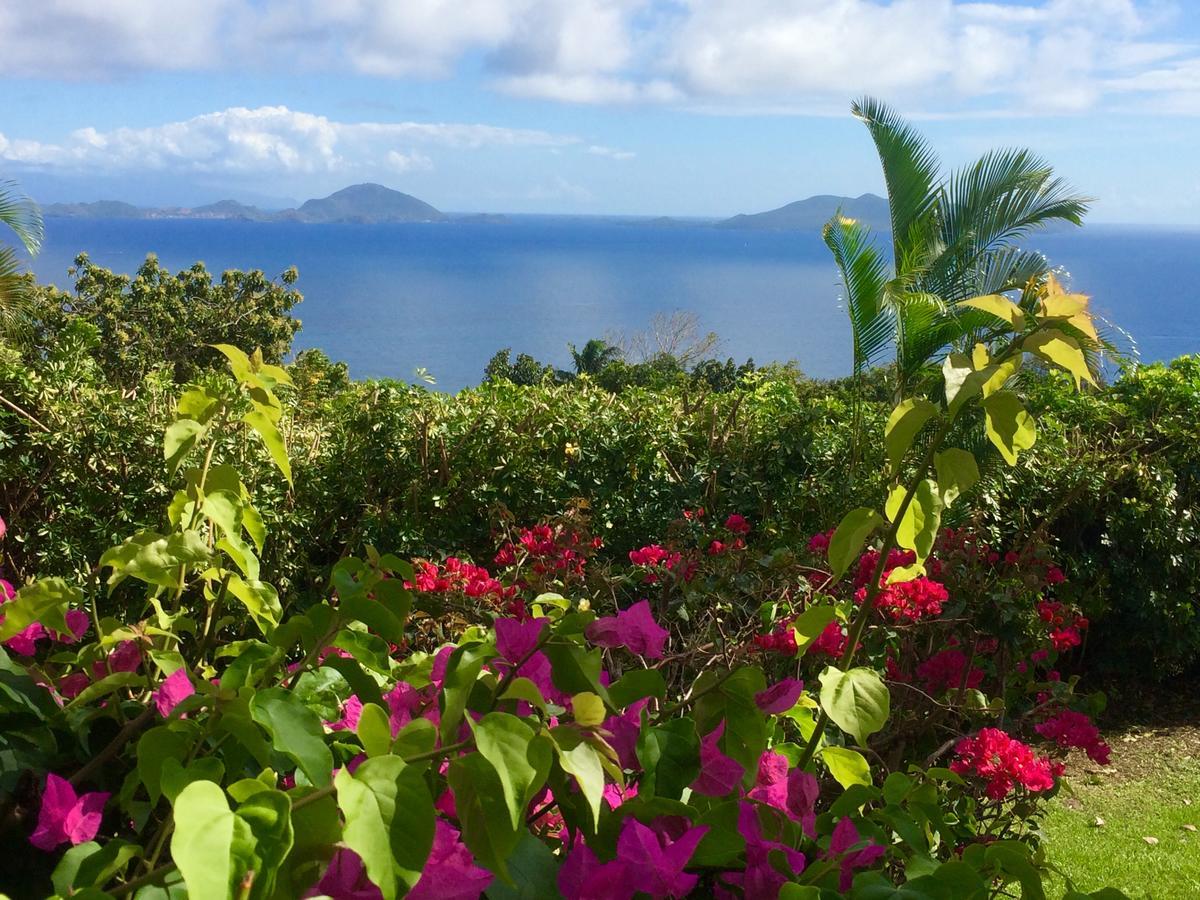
[821,214,894,374]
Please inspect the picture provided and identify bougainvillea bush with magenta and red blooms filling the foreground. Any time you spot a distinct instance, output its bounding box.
[0,280,1123,900]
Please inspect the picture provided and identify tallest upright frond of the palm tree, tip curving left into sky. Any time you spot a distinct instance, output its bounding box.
[851,97,941,268]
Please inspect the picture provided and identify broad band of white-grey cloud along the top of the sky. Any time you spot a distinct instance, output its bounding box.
[0,0,1200,114]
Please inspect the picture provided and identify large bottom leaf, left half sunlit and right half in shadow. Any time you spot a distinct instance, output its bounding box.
[334,756,434,900]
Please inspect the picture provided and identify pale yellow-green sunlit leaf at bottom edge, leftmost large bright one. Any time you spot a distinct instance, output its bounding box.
[170,781,241,900]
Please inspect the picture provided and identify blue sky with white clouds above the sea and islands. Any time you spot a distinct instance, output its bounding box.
[0,0,1200,223]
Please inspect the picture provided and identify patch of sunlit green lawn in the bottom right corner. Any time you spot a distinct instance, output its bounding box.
[1044,738,1200,900]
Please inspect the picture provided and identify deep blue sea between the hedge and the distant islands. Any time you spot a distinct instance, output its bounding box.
[34,216,1200,390]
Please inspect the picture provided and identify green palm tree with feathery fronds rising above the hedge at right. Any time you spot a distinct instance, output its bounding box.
[823,97,1090,397]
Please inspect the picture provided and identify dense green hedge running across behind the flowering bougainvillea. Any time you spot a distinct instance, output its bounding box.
[0,334,1200,674]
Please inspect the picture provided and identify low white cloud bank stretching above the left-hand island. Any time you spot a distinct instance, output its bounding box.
[0,107,626,174]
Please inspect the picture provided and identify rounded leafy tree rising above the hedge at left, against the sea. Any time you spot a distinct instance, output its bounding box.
[31,253,301,389]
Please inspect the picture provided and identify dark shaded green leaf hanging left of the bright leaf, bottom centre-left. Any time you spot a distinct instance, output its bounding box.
[449,744,520,878]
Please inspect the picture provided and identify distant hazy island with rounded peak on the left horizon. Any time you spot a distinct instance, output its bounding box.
[42,184,449,224]
